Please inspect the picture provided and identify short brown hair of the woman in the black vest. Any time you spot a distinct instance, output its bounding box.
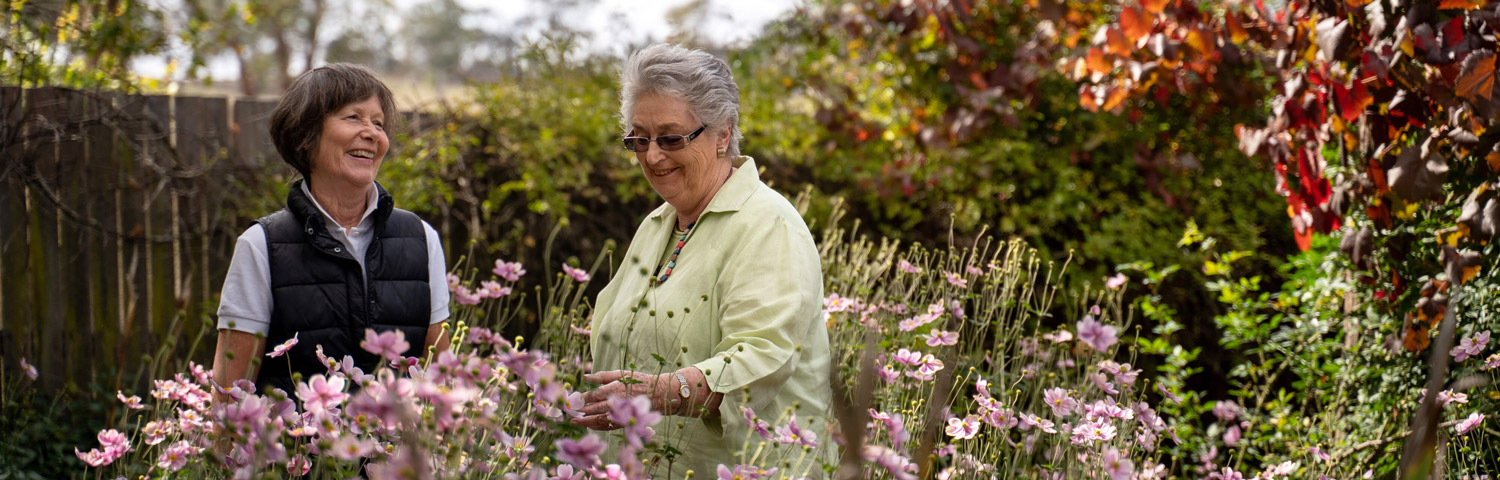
[270,63,401,179]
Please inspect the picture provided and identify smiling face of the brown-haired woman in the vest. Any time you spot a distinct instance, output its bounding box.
[311,96,390,194]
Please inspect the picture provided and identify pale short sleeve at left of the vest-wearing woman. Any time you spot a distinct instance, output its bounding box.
[219,225,272,335]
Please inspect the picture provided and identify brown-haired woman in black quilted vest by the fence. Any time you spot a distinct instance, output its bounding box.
[213,63,449,393]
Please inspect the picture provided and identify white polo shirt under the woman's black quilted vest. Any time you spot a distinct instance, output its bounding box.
[219,182,449,341]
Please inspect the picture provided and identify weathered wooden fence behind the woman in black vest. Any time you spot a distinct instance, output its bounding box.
[0,87,417,390]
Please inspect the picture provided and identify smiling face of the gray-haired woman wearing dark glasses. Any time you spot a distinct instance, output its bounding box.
[630,93,731,218]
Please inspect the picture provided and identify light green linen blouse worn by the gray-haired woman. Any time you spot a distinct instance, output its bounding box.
[591,156,836,479]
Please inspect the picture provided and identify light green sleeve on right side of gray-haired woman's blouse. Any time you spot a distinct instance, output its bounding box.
[695,218,822,419]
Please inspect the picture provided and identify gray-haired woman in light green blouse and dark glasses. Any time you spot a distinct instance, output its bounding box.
[575,44,834,479]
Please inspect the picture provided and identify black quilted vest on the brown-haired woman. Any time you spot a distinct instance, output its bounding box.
[257,180,432,395]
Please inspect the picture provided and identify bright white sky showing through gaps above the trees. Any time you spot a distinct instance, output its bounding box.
[134,0,800,80]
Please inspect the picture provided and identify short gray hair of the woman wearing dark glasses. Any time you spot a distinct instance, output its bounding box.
[620,44,740,158]
